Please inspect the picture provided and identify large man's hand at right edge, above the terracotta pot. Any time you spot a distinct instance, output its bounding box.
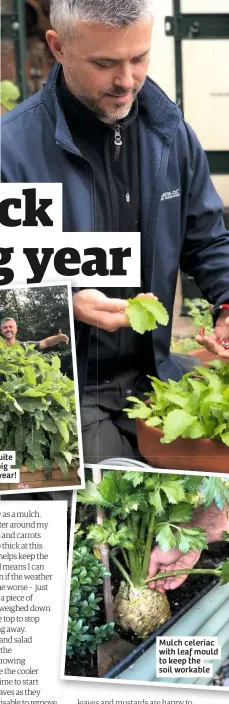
[196,310,229,360]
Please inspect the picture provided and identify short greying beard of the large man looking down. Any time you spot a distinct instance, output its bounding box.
[65,75,143,124]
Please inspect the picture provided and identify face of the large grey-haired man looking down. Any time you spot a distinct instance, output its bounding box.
[54,20,153,123]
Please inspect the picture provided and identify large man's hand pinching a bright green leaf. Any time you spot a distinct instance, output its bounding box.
[73,288,130,332]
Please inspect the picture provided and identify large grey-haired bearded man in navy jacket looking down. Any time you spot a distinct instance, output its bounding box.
[2,0,229,463]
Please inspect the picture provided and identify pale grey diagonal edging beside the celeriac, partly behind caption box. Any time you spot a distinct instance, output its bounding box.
[105,584,229,685]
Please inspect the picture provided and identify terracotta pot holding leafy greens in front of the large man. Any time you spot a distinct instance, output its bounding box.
[136,418,229,474]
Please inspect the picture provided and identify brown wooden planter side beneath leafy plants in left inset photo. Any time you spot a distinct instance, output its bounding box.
[0,462,80,492]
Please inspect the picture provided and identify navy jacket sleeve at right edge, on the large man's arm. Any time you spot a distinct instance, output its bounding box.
[181,125,229,317]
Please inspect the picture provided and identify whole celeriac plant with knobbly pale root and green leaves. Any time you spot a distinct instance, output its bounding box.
[78,471,229,637]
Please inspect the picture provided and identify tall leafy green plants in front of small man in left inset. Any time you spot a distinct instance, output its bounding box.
[0,340,78,477]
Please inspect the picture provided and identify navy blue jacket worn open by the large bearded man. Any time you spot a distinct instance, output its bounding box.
[2,64,229,391]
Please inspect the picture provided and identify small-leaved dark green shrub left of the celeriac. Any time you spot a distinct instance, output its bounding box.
[66,530,114,658]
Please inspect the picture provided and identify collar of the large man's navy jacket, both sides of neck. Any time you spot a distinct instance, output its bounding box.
[43,63,182,155]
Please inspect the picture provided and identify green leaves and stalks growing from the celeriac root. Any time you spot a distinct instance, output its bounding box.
[77,470,229,587]
